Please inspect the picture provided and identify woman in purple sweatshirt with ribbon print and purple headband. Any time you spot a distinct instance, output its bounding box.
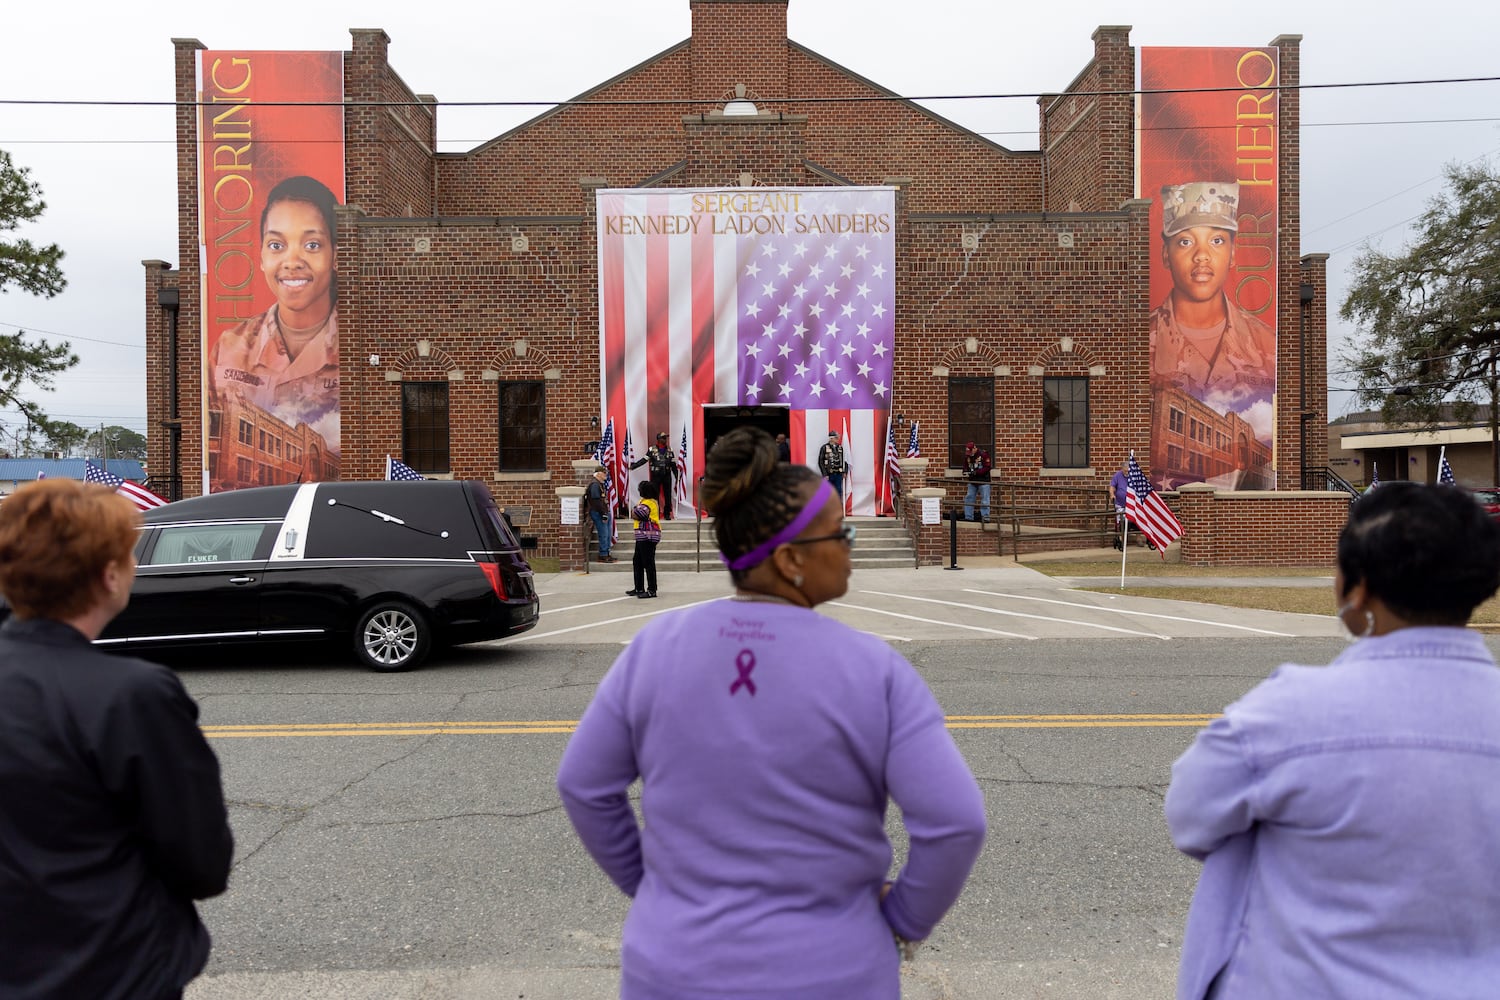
[558,427,986,1000]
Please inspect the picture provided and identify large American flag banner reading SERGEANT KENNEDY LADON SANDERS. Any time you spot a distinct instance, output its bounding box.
[597,187,896,514]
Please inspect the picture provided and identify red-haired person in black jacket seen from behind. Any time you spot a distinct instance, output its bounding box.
[0,480,234,1000]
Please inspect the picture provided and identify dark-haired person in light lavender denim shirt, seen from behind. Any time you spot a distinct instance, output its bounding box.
[1166,483,1500,1000]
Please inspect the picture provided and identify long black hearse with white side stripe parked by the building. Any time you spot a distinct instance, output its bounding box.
[0,480,540,672]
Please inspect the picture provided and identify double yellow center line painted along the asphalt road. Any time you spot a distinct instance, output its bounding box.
[203,714,1218,739]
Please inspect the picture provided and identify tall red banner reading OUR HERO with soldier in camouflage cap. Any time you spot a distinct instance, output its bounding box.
[1136,48,1281,489]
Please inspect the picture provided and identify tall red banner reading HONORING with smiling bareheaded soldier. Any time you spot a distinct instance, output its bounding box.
[198,51,344,490]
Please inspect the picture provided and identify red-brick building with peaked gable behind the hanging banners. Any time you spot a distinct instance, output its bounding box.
[144,0,1326,563]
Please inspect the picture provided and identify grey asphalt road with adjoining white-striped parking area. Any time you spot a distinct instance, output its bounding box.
[174,570,1374,1000]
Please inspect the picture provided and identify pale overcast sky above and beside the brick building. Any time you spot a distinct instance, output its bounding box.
[0,0,1500,446]
